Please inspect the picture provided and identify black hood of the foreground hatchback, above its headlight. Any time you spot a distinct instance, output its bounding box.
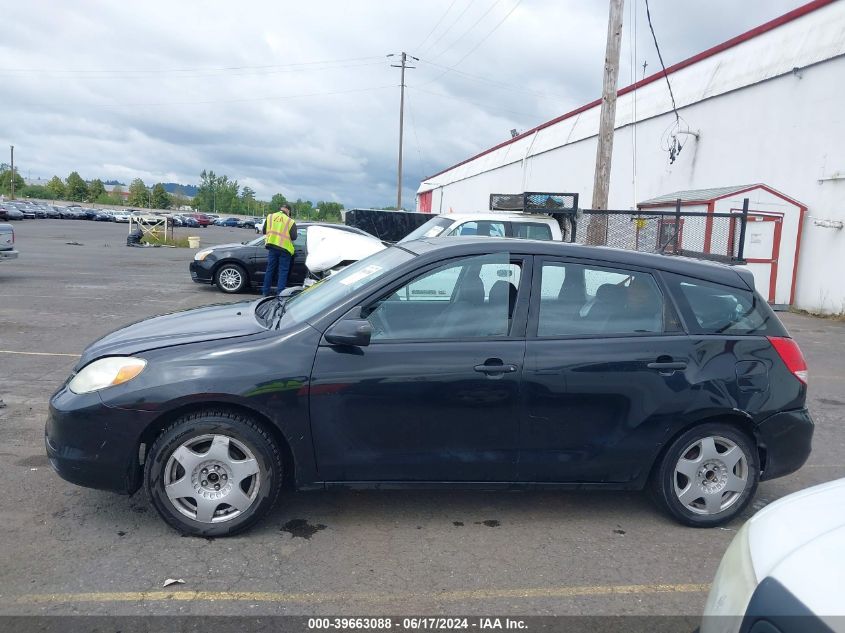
[75,301,265,370]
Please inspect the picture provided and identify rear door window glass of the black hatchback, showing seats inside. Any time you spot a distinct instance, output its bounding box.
[537,262,678,336]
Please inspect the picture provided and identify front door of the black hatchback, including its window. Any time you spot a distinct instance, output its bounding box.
[310,253,527,482]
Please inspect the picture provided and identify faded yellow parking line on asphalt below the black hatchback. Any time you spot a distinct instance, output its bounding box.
[14,584,710,604]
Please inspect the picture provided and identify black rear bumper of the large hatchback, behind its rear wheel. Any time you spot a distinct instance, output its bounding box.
[757,409,815,481]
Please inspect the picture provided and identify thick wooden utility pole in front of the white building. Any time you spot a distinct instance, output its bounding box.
[587,0,625,244]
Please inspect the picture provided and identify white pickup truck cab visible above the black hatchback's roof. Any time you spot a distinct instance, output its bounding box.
[400,211,563,242]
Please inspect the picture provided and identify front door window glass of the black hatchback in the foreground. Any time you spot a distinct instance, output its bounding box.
[363,253,521,341]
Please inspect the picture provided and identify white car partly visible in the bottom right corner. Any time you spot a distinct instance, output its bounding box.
[701,479,845,633]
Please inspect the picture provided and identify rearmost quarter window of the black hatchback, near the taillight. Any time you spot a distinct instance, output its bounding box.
[666,274,787,336]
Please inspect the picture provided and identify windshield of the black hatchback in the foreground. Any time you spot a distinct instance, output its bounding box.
[256,246,414,328]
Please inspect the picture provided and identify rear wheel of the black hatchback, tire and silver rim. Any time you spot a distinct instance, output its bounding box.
[650,423,760,527]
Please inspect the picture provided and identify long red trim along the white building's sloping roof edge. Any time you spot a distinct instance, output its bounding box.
[424,0,836,180]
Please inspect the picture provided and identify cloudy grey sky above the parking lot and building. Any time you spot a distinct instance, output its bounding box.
[0,0,803,208]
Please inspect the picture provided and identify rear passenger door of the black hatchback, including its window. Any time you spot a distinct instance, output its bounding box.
[519,258,694,483]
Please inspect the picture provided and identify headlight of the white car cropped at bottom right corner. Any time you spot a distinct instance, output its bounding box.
[701,523,757,633]
